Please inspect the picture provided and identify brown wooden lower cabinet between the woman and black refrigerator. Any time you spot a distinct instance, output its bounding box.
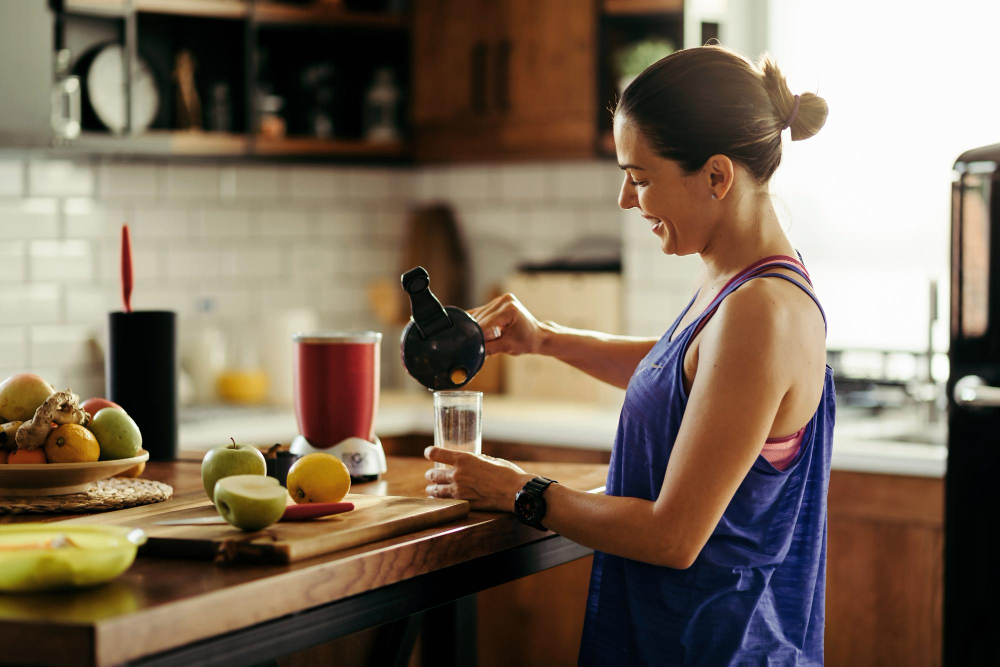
[826,471,944,667]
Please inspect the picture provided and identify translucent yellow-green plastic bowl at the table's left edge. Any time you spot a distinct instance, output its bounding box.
[0,523,146,593]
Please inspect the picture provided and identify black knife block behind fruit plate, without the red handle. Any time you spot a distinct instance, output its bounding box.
[105,310,178,461]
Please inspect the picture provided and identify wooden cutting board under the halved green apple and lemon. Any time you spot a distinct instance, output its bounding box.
[70,493,469,564]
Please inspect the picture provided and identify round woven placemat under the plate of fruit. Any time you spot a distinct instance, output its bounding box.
[0,477,174,514]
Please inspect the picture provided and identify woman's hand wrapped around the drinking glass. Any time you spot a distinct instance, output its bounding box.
[424,447,533,512]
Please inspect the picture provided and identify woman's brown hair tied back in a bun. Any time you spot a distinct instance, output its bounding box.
[615,45,828,184]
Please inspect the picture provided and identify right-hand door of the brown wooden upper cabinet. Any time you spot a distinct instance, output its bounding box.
[495,0,597,157]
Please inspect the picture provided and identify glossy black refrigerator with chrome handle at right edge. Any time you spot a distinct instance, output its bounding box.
[944,144,1000,666]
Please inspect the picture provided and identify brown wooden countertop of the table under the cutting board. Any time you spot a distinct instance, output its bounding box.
[0,454,607,665]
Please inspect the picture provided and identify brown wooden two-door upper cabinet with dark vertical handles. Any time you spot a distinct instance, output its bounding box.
[413,0,597,161]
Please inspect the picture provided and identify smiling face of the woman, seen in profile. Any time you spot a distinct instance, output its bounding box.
[614,114,722,255]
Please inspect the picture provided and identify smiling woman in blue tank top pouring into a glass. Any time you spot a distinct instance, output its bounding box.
[427,46,835,665]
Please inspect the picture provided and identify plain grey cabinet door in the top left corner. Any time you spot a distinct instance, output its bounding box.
[0,0,53,146]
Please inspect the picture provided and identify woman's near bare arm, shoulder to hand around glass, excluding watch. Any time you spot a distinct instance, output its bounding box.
[426,281,801,568]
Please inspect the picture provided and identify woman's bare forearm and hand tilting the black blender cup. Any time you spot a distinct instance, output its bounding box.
[469,294,656,389]
